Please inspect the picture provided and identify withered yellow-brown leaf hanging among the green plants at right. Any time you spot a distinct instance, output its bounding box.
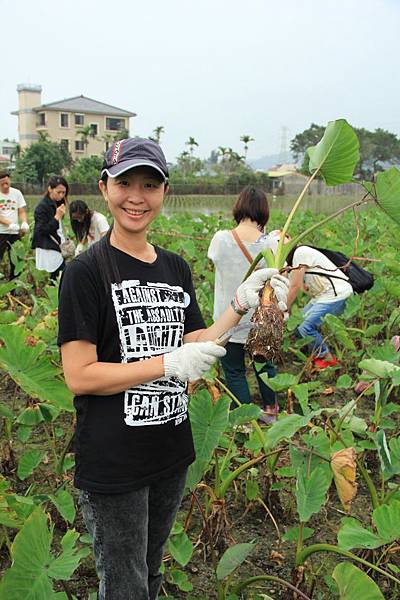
[331,448,357,512]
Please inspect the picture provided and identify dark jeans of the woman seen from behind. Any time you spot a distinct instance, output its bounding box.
[221,342,276,408]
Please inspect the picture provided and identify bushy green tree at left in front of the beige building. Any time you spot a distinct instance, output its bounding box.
[13,133,73,185]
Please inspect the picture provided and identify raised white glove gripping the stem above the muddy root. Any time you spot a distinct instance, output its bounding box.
[235,268,289,312]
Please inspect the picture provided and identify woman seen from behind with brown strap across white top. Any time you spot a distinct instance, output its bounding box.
[208,186,279,423]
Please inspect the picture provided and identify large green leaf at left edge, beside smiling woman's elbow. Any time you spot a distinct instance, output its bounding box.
[0,325,74,412]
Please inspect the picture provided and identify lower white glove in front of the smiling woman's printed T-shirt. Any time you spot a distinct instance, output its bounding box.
[164,342,226,381]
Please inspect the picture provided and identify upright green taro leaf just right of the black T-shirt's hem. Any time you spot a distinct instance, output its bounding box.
[186,390,230,489]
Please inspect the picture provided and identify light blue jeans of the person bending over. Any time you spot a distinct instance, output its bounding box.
[297,300,346,358]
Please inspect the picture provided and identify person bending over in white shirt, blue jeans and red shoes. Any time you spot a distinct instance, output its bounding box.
[286,246,353,369]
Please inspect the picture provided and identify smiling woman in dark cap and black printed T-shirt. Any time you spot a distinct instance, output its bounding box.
[58,138,287,600]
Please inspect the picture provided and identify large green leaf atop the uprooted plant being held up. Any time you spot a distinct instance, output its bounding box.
[307,119,360,185]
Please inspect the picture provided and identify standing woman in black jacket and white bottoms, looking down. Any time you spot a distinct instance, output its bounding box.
[32,176,69,280]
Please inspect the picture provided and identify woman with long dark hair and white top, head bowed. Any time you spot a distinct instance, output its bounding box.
[69,200,110,256]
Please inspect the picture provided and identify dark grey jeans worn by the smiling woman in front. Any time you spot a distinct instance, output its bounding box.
[79,469,187,600]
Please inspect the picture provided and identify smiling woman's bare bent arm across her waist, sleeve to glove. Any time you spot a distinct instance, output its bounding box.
[61,340,164,396]
